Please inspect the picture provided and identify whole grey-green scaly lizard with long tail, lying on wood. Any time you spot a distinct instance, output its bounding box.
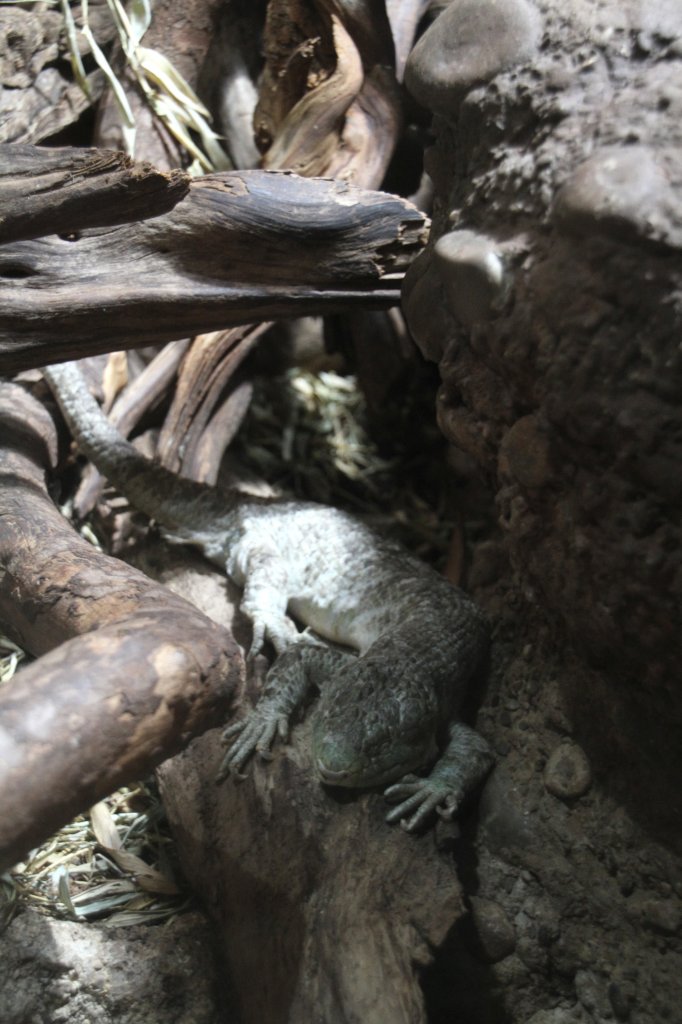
[44,364,493,830]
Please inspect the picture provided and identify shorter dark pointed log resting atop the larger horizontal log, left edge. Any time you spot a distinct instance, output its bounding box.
[0,145,189,243]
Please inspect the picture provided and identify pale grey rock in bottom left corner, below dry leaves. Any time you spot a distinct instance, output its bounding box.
[0,909,222,1024]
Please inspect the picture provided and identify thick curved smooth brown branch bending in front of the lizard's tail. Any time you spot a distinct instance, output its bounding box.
[0,384,243,869]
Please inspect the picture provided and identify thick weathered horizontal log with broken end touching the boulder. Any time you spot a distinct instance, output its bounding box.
[0,163,425,374]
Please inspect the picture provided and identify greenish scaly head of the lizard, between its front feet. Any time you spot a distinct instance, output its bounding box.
[312,658,437,787]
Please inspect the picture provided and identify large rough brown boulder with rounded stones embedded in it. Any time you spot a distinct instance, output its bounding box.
[404,0,682,723]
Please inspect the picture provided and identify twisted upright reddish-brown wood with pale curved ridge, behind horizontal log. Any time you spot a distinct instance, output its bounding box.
[254,0,401,187]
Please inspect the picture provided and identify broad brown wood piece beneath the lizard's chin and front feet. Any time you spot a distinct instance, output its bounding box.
[160,723,464,1024]
